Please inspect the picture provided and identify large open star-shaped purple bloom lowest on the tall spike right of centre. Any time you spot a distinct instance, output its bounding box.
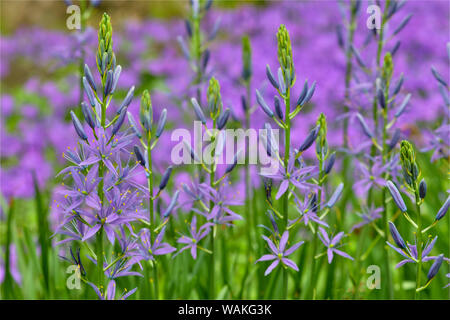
[256,231,304,276]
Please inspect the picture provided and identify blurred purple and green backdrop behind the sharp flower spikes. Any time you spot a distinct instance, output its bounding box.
[0,0,450,297]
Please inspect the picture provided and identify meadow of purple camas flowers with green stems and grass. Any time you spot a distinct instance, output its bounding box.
[0,0,450,299]
